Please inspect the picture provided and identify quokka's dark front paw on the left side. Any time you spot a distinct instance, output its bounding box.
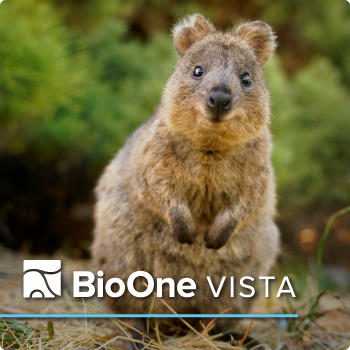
[171,207,197,244]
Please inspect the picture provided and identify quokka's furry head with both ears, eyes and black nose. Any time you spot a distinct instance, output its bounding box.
[163,14,276,149]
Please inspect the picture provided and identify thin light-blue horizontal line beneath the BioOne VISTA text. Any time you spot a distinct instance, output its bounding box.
[0,314,298,318]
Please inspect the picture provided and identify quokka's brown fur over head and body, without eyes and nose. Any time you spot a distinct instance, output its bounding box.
[93,15,279,327]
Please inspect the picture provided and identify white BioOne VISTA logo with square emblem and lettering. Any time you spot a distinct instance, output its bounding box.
[23,260,295,298]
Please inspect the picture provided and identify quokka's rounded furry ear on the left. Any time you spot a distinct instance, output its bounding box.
[173,14,215,56]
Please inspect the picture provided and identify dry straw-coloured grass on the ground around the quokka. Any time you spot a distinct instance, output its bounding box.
[0,250,350,350]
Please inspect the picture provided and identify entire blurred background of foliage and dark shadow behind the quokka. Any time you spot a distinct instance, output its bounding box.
[0,0,350,276]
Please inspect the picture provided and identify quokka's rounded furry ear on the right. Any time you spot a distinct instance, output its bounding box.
[234,21,277,66]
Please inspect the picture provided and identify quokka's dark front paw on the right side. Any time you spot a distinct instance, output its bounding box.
[205,219,236,249]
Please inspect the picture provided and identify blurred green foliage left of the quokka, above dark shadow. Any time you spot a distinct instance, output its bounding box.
[0,0,175,162]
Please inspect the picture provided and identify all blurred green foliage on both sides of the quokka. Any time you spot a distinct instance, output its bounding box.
[0,0,350,210]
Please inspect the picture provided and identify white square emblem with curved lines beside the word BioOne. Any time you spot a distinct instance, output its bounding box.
[23,260,61,298]
